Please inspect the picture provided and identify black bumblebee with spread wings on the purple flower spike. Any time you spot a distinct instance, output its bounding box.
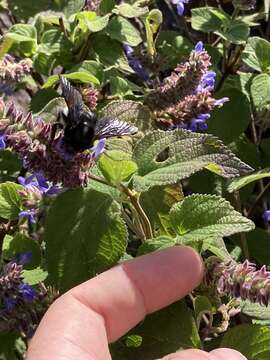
[60,76,138,152]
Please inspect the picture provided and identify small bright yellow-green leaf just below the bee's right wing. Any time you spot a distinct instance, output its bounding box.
[98,150,137,186]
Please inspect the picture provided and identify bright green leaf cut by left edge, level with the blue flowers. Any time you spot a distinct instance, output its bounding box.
[0,182,23,220]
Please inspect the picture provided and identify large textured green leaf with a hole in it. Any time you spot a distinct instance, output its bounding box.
[133,129,252,191]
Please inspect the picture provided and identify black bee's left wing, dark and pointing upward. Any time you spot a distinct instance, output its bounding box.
[60,76,84,121]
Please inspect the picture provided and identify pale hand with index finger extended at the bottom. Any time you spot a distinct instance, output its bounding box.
[27,246,247,360]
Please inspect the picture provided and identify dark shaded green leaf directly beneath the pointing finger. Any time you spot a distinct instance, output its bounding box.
[111,301,200,360]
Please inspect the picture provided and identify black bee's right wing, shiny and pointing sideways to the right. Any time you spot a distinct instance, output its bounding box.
[95,118,138,139]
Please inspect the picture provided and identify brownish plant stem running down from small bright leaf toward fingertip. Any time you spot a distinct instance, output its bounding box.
[121,184,153,239]
